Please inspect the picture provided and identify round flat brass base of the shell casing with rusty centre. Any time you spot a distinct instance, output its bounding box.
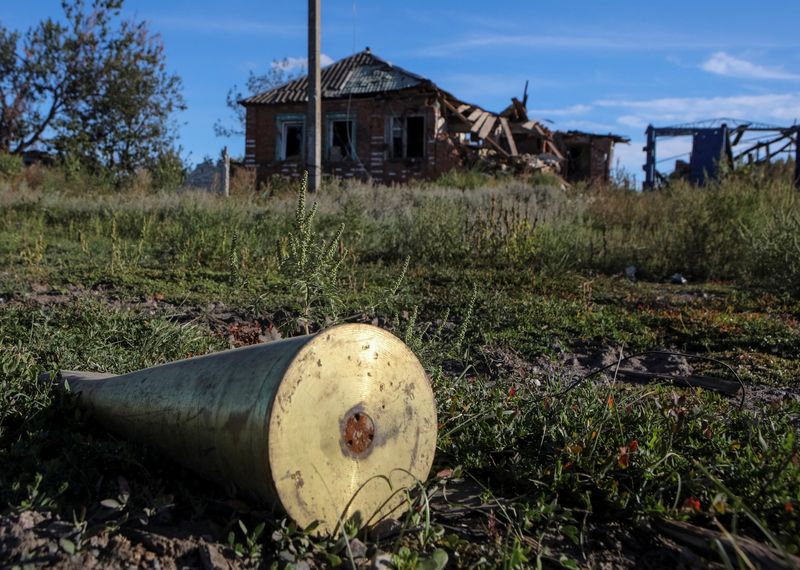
[269,325,436,532]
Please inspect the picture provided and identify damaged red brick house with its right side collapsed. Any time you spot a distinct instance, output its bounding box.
[240,48,624,185]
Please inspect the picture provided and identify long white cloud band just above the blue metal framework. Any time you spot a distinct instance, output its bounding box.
[595,92,800,128]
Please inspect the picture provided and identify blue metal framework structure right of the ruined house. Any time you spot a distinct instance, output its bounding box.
[642,119,800,190]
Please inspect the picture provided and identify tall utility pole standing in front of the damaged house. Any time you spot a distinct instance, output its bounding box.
[306,0,322,192]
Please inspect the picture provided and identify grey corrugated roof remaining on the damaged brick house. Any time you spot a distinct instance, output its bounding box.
[240,50,429,105]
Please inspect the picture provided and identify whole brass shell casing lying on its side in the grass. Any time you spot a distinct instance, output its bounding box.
[48,324,436,532]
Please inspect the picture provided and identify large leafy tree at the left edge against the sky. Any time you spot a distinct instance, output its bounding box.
[0,0,185,175]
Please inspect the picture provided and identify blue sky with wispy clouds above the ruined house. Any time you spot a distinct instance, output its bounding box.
[0,0,800,180]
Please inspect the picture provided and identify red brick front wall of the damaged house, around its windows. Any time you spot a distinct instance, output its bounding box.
[245,93,459,185]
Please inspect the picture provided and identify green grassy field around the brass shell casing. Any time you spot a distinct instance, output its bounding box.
[0,166,800,568]
